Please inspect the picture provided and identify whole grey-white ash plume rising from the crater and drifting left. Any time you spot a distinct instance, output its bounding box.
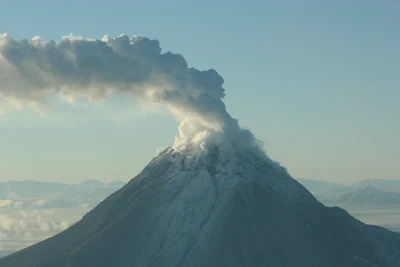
[0,34,264,159]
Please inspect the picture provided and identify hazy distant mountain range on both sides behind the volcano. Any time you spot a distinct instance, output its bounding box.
[0,178,400,209]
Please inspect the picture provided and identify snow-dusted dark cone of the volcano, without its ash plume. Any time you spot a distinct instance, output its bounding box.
[0,148,400,267]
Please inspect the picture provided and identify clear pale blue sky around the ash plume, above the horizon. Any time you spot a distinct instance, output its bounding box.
[0,0,400,183]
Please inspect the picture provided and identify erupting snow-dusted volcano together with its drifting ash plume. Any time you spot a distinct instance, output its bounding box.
[0,34,400,267]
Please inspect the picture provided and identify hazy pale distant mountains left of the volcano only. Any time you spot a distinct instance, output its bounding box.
[0,180,125,209]
